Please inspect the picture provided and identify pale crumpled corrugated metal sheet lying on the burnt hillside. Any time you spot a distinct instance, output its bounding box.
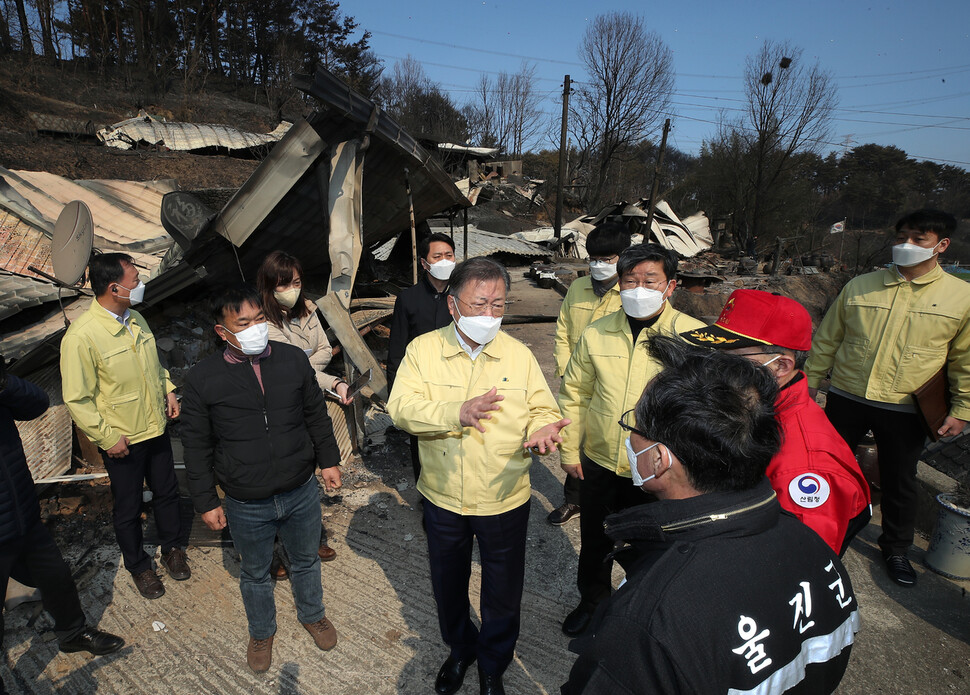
[97,113,291,151]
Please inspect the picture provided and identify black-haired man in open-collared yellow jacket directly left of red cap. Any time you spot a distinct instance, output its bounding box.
[559,244,704,637]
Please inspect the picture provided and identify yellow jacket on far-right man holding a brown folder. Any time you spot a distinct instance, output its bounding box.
[805,265,970,420]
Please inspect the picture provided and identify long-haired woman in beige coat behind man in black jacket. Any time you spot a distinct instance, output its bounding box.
[256,251,352,579]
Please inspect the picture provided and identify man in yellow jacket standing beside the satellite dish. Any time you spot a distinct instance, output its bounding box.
[61,253,191,599]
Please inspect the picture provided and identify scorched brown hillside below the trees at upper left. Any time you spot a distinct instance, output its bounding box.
[0,56,280,190]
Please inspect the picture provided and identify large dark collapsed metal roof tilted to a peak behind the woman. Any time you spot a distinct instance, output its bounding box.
[179,69,468,277]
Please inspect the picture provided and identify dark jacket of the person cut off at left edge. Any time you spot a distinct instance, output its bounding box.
[0,374,50,543]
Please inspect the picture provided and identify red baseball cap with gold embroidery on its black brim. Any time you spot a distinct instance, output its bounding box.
[680,290,812,350]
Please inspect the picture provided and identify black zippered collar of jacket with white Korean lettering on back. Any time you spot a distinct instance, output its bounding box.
[605,478,781,545]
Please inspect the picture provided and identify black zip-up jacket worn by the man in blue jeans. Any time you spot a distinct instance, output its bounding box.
[181,341,340,513]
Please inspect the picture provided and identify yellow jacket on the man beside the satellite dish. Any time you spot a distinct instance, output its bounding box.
[61,300,175,449]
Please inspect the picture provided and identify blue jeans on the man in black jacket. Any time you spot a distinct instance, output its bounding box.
[225,475,324,639]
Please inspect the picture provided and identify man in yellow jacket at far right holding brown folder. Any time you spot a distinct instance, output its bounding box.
[805,209,970,586]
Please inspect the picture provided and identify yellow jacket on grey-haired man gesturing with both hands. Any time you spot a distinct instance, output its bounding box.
[387,324,569,516]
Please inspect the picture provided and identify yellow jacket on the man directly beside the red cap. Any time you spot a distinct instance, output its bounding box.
[559,303,705,478]
